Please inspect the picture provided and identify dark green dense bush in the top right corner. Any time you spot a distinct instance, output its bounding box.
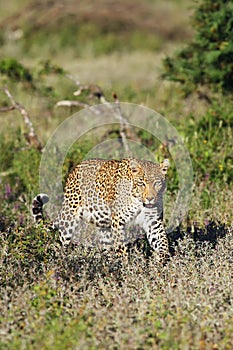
[164,0,233,92]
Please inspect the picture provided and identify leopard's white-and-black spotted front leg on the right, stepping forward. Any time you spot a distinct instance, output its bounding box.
[135,208,169,263]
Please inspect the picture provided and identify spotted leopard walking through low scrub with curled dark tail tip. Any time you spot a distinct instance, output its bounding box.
[32,158,169,262]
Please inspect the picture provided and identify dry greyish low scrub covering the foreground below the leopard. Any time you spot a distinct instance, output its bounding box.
[1,221,233,349]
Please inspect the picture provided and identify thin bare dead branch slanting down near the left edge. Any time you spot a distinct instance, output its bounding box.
[0,87,42,151]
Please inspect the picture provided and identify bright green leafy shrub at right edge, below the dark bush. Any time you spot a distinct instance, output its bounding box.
[186,101,233,185]
